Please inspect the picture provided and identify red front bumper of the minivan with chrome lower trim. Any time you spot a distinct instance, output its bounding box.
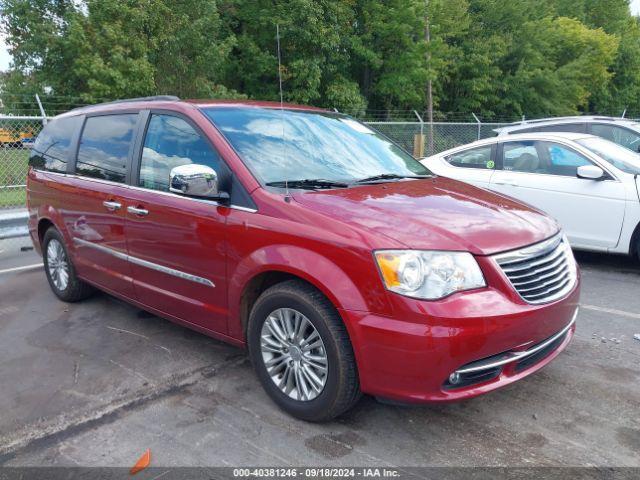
[341,282,579,403]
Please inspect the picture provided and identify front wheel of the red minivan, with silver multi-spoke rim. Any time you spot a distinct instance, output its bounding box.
[247,280,360,422]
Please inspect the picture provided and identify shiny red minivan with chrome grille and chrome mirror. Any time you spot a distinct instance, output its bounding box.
[27,97,579,421]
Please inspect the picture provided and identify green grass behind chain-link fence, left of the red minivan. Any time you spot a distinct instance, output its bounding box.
[0,147,29,208]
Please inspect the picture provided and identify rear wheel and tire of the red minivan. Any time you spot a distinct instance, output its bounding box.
[42,227,95,302]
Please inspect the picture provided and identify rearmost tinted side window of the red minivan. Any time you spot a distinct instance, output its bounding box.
[29,117,80,173]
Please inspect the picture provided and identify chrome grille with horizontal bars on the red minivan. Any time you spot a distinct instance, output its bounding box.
[493,234,577,303]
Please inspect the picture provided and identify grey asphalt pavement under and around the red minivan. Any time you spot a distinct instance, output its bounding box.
[0,252,640,467]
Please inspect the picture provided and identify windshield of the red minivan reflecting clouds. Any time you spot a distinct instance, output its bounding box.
[203,107,430,186]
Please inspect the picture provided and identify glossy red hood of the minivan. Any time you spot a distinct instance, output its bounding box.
[293,177,559,255]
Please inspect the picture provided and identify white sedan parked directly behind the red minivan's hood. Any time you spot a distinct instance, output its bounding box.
[421,133,640,256]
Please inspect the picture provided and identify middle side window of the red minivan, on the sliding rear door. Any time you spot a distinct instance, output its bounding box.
[76,113,138,183]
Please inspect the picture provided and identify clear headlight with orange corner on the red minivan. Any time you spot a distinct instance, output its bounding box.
[374,250,486,300]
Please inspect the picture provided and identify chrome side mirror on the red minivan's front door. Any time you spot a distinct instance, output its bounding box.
[169,163,229,200]
